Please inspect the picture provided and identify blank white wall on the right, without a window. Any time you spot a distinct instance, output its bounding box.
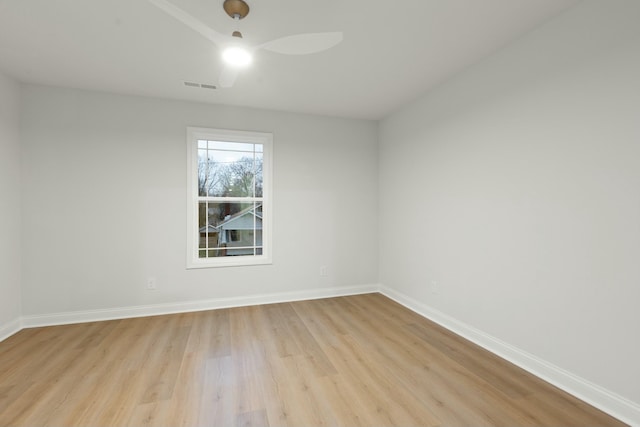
[379,0,640,412]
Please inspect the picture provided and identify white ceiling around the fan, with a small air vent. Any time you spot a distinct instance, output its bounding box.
[0,0,579,120]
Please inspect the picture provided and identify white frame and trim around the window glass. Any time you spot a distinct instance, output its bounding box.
[187,127,273,269]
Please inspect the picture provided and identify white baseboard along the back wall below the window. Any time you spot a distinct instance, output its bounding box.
[20,284,379,333]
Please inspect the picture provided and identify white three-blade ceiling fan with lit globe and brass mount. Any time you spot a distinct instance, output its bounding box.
[149,0,343,88]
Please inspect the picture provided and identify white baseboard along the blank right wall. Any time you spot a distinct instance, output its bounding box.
[380,285,640,427]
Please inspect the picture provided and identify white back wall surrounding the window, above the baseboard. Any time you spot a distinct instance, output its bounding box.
[21,85,378,317]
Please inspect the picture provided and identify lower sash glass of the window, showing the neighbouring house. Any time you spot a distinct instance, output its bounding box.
[199,202,262,258]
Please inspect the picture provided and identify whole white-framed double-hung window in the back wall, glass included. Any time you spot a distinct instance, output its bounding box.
[187,128,272,268]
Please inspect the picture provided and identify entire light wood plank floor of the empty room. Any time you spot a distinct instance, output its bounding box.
[0,294,624,426]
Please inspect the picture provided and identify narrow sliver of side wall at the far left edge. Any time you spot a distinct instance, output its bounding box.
[0,73,21,340]
